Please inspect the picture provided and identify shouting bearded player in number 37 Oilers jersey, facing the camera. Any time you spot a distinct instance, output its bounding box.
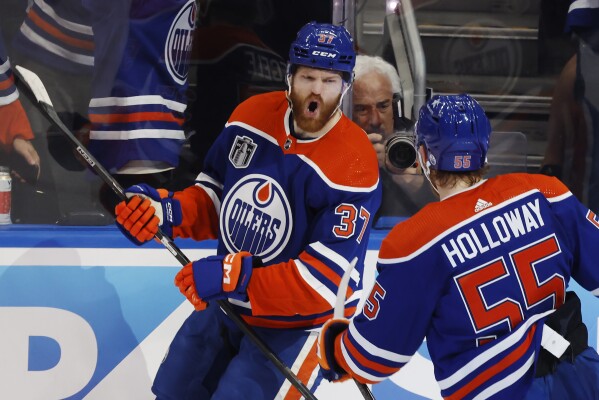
[116,22,381,400]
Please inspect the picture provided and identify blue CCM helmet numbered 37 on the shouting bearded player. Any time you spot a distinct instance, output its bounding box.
[289,21,356,82]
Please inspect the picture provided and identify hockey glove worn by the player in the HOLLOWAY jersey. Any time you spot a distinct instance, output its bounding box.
[318,318,350,382]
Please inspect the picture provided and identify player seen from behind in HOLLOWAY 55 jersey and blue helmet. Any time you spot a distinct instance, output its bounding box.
[319,95,599,400]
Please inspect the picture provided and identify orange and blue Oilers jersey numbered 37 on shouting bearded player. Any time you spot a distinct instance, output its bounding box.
[173,92,381,328]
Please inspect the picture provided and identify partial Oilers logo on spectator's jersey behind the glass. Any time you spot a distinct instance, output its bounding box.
[164,0,196,85]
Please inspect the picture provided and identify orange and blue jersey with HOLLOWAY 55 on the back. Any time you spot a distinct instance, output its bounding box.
[335,174,599,399]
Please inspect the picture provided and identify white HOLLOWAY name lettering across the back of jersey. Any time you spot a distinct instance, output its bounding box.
[441,199,545,268]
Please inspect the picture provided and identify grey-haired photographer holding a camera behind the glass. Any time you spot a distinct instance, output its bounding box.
[352,55,436,223]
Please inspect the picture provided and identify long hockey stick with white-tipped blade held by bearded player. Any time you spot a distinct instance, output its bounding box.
[13,65,317,400]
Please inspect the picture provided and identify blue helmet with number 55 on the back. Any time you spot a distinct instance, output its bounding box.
[416,94,491,172]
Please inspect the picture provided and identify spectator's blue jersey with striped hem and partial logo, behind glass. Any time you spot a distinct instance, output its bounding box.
[86,0,196,171]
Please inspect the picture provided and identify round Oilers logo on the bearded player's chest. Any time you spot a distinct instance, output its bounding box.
[220,174,293,262]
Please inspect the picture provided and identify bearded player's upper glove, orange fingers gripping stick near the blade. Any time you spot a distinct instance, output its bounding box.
[114,183,183,245]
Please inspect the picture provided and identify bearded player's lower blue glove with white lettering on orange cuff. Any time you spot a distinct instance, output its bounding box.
[175,251,258,311]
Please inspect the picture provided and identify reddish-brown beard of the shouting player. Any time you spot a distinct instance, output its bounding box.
[290,91,341,133]
